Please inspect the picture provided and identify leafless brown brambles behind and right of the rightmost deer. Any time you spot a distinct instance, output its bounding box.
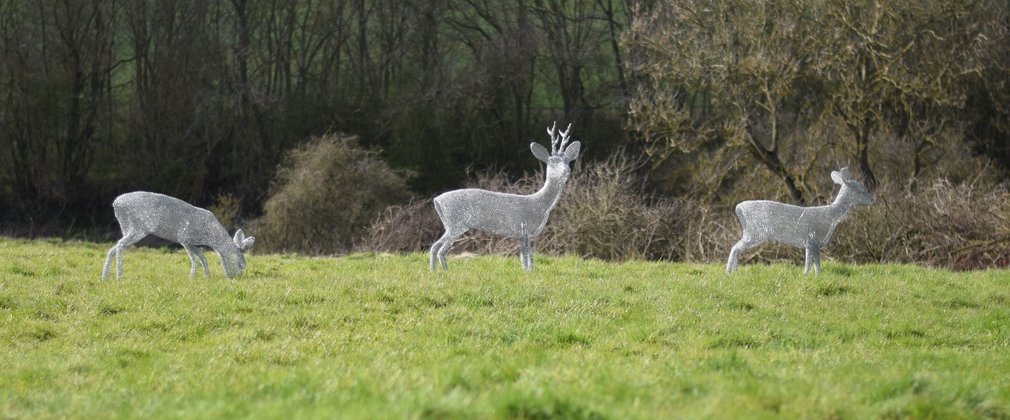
[707,176,1010,270]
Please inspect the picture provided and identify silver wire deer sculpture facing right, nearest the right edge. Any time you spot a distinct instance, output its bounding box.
[726,168,874,274]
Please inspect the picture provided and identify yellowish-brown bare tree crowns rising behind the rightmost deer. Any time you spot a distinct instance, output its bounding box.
[624,0,1010,204]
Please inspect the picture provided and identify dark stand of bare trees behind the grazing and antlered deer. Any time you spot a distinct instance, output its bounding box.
[0,0,628,230]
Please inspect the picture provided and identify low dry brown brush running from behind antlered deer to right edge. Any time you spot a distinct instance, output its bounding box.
[360,151,1010,270]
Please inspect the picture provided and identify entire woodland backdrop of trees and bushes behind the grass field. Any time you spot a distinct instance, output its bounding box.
[0,0,1010,269]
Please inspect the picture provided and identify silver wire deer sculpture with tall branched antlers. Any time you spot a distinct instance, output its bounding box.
[428,121,582,271]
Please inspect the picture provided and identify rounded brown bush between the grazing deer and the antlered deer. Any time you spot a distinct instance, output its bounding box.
[248,134,409,253]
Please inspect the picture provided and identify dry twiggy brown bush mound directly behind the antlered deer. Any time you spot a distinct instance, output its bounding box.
[360,153,695,260]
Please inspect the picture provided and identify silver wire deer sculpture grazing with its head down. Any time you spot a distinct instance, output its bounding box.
[102,191,256,279]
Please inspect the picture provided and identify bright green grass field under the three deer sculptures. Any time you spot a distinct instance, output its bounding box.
[0,239,1010,418]
